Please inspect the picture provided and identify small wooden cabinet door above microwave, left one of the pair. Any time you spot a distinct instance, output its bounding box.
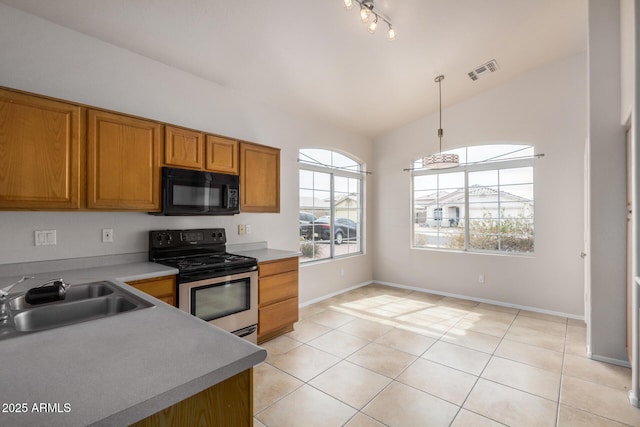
[164,126,204,169]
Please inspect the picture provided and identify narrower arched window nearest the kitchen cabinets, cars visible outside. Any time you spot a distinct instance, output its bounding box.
[299,148,364,262]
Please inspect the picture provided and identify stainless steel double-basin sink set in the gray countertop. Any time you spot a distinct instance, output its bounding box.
[0,281,154,340]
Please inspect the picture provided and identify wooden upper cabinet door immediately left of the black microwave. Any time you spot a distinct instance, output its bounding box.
[87,110,162,211]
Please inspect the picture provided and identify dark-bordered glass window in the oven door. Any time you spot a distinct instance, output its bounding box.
[191,278,251,321]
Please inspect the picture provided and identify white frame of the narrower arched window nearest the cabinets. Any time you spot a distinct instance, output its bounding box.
[298,147,366,265]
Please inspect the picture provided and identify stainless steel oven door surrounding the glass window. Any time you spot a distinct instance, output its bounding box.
[178,271,258,342]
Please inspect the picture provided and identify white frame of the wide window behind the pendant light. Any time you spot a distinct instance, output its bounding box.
[410,157,536,257]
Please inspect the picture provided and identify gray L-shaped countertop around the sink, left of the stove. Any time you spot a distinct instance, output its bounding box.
[0,262,266,426]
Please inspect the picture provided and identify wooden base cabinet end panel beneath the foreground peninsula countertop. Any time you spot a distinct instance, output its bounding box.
[132,368,253,427]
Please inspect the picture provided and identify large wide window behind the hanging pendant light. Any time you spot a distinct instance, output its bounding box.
[412,145,534,254]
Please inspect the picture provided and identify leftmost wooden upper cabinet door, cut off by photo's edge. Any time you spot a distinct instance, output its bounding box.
[0,89,84,209]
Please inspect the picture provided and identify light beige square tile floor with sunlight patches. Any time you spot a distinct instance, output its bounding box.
[254,285,640,427]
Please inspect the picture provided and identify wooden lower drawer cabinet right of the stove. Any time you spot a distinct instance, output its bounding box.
[258,257,298,343]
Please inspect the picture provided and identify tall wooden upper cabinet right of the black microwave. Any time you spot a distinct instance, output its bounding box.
[240,142,280,212]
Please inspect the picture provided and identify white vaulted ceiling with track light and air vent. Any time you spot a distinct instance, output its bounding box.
[0,0,587,137]
